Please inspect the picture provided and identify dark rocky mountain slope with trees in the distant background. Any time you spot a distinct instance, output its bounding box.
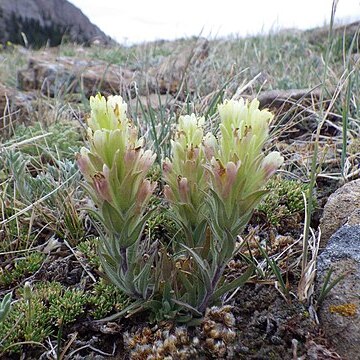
[0,0,111,47]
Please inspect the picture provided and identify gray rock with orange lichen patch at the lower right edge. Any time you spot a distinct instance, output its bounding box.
[316,225,360,359]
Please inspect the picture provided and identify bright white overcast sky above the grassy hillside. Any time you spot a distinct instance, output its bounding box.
[69,0,360,44]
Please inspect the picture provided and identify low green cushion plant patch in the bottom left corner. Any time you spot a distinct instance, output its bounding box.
[0,280,129,352]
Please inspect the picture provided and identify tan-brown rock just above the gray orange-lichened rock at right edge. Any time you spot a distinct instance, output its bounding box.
[320,179,360,247]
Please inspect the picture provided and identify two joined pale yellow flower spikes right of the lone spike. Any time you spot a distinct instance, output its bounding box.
[164,100,283,313]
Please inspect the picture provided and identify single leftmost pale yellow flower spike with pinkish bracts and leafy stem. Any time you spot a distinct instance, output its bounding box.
[76,95,156,298]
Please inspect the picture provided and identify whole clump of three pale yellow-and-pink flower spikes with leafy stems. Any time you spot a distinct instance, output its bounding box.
[77,95,283,321]
